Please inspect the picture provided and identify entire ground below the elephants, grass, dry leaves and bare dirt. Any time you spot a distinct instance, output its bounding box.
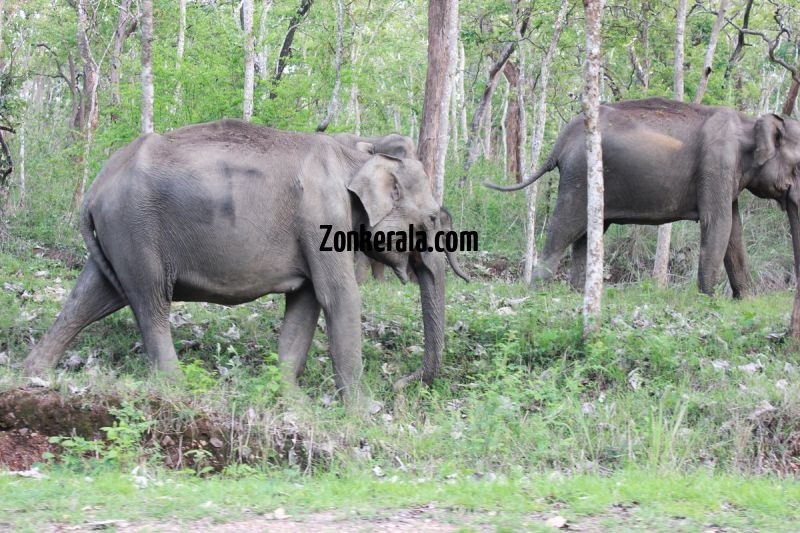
[0,244,800,531]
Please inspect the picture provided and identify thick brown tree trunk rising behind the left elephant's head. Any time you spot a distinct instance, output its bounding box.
[417,0,458,200]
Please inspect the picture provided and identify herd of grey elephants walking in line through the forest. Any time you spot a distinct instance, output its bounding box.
[24,98,800,398]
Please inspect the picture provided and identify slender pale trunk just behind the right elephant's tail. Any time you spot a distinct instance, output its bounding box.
[523,0,569,283]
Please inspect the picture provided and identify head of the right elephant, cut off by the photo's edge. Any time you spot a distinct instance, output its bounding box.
[747,113,800,304]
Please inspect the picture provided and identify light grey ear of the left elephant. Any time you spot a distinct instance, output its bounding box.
[347,154,400,227]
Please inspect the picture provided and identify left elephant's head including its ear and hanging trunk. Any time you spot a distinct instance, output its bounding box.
[347,154,468,388]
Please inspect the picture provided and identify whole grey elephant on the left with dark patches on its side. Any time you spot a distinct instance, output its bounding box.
[25,120,468,398]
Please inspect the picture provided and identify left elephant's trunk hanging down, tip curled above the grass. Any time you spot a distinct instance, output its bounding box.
[394,247,445,390]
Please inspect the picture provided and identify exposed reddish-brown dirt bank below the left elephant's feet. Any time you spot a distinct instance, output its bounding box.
[0,387,318,473]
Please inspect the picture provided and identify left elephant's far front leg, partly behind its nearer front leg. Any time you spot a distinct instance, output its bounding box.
[278,283,320,386]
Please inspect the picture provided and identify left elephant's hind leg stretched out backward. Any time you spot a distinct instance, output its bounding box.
[24,257,127,374]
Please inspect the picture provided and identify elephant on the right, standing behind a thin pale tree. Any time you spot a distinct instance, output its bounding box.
[487,98,800,298]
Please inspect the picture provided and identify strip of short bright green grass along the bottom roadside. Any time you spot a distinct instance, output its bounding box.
[0,470,800,531]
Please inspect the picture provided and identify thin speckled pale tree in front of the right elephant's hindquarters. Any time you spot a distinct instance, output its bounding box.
[582,0,604,336]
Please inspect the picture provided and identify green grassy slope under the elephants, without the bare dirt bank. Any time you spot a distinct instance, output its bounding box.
[0,247,800,530]
